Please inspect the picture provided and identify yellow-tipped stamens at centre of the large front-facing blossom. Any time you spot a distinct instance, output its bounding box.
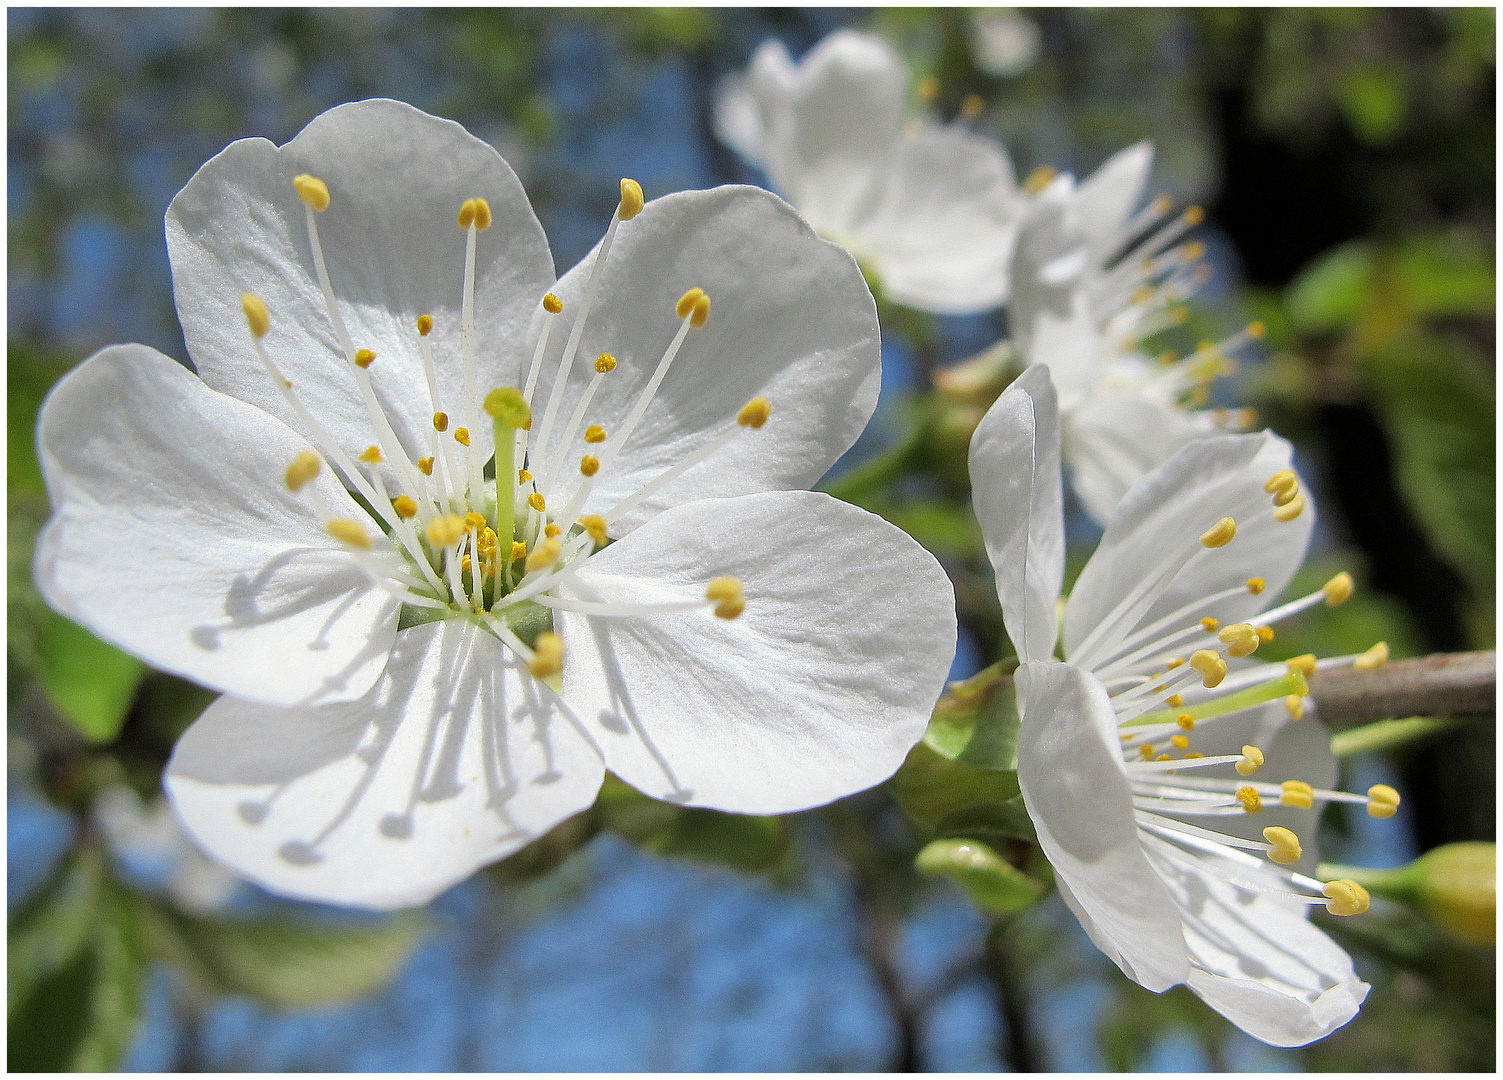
[240,174,771,679]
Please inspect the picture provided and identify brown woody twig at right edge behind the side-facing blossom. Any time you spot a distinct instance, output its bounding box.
[1311,652,1497,727]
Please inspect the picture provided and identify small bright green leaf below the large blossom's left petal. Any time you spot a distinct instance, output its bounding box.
[41,614,146,744]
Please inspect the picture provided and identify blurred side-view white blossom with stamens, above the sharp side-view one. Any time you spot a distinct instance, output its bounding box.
[1009,143,1263,523]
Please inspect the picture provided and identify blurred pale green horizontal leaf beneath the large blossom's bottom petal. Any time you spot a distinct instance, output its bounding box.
[141,900,433,1009]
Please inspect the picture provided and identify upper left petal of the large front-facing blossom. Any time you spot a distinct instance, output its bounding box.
[167,99,553,468]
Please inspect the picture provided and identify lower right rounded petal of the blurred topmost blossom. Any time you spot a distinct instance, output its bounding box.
[855,126,1022,314]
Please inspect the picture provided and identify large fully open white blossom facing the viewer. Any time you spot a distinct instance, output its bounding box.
[36,101,954,909]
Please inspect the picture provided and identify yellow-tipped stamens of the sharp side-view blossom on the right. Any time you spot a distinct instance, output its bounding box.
[1070,470,1399,915]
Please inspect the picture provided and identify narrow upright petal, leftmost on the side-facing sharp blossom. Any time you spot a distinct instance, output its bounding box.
[969,364,1064,661]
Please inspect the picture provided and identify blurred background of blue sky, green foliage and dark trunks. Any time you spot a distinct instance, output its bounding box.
[8,8,1495,1071]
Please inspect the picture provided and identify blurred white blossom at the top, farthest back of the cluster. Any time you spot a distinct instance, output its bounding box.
[715,30,1022,314]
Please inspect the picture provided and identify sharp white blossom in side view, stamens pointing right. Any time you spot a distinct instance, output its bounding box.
[971,365,1398,1045]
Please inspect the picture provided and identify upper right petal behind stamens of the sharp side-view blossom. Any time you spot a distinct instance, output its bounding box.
[1064,433,1315,658]
